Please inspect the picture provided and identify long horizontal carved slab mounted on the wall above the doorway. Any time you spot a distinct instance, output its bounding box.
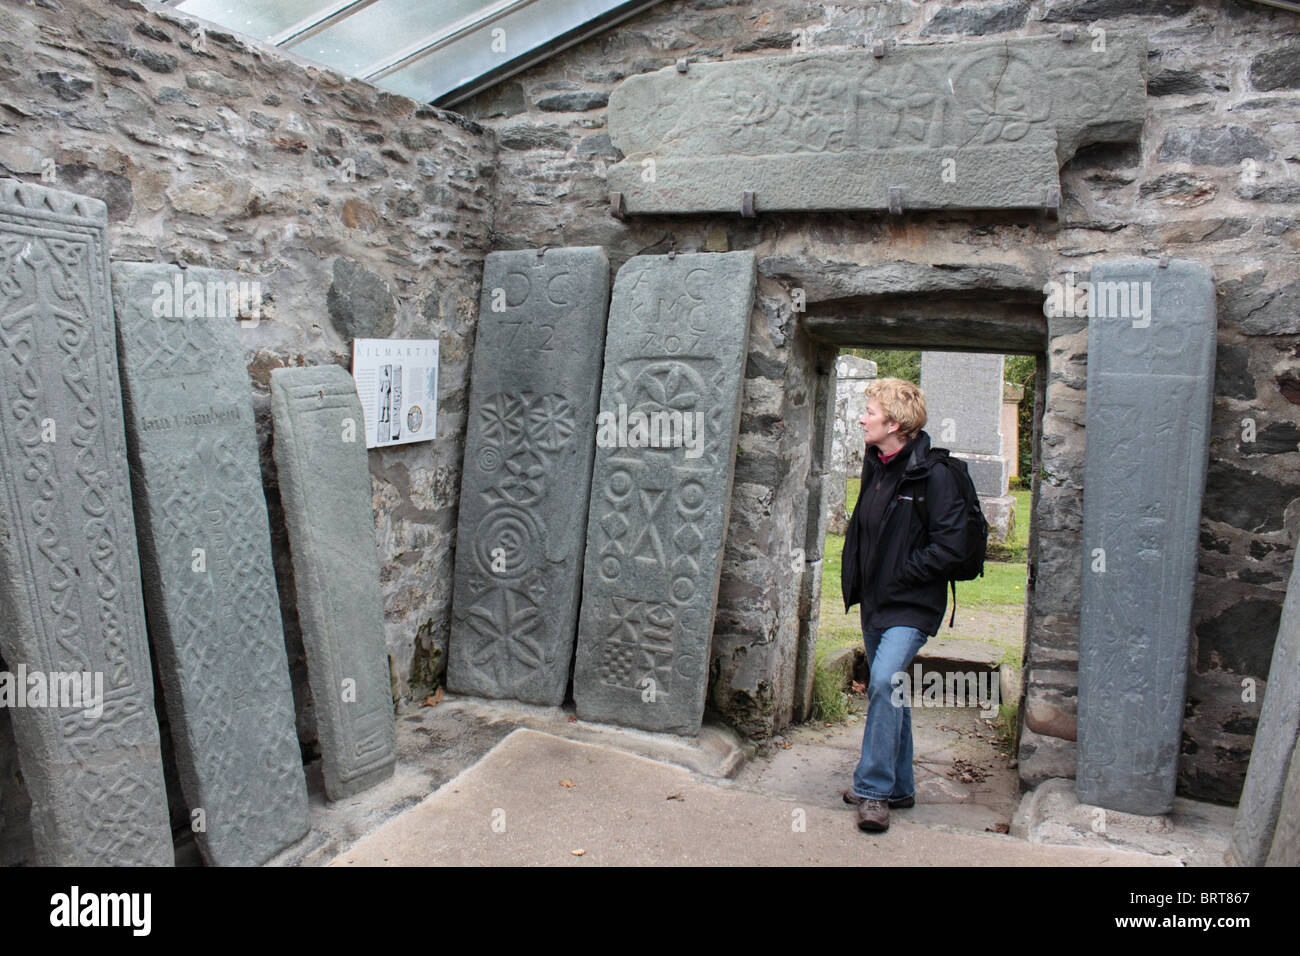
[608,31,1147,213]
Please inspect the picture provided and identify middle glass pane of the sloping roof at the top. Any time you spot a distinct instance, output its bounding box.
[289,0,498,77]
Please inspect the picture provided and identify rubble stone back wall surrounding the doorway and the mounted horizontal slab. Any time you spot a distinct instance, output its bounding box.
[458,0,1300,801]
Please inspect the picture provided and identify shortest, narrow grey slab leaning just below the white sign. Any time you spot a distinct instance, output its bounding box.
[270,365,397,800]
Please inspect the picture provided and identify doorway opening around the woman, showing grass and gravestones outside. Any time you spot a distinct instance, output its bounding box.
[738,282,1048,832]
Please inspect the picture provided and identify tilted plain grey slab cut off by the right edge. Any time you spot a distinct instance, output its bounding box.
[1229,538,1300,866]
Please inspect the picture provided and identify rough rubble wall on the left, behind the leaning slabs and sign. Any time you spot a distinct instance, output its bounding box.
[0,0,495,749]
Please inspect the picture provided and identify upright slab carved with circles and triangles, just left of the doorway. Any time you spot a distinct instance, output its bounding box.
[573,252,754,734]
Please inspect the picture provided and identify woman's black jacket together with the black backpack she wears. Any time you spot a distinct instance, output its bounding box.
[840,432,966,635]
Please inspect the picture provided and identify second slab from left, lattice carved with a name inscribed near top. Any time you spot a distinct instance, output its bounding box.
[113,263,307,865]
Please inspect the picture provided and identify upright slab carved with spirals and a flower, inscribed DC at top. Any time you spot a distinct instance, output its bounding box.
[447,247,610,705]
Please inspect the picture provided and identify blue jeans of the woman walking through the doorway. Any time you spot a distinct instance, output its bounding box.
[853,627,928,800]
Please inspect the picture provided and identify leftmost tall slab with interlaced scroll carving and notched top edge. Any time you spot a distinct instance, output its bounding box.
[0,179,173,866]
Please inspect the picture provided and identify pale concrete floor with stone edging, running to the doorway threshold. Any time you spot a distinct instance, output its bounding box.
[250,696,1231,866]
